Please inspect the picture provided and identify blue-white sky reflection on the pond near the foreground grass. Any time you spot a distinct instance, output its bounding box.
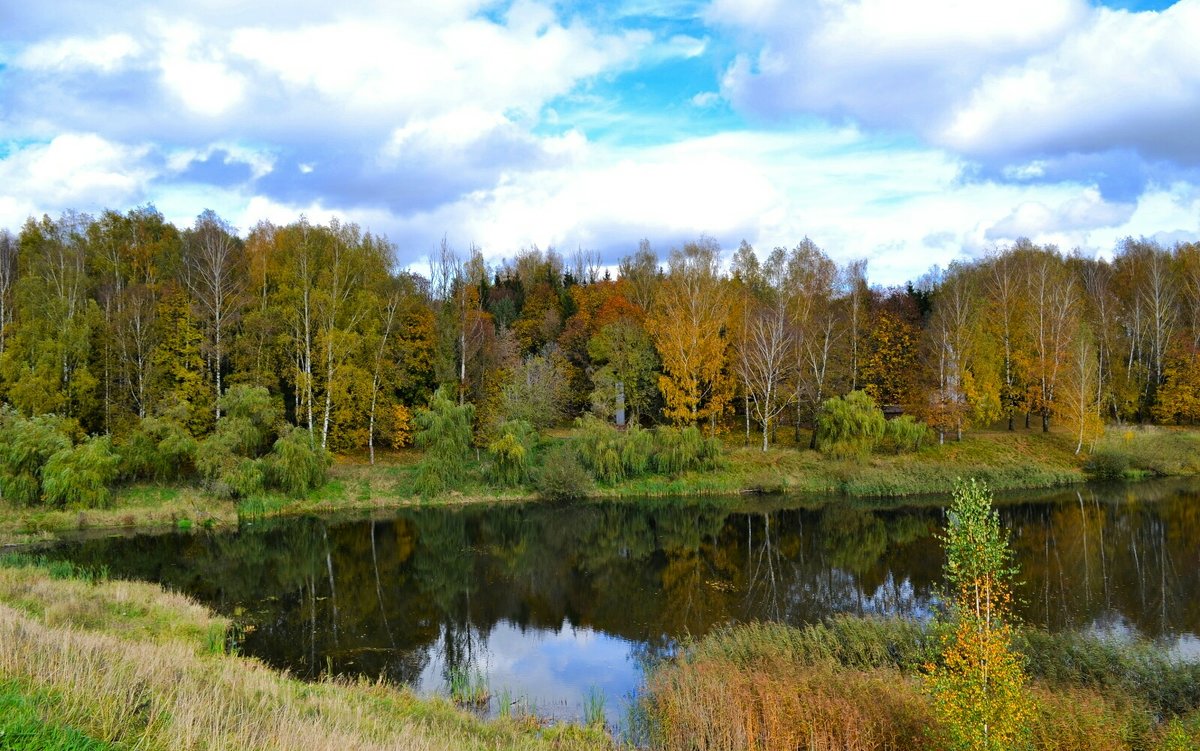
[416,620,642,725]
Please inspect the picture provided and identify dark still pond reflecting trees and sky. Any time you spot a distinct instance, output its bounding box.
[44,481,1200,723]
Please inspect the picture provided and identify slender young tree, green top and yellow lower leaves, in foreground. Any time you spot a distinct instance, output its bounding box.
[925,480,1033,751]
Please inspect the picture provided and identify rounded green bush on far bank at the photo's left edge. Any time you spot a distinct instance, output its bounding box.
[0,410,71,506]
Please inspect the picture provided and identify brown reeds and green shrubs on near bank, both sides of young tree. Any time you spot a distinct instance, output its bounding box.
[643,618,1200,751]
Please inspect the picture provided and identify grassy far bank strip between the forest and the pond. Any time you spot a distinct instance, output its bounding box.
[0,428,1200,546]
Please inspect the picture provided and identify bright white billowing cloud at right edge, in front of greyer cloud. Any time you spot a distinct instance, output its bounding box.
[937,0,1200,163]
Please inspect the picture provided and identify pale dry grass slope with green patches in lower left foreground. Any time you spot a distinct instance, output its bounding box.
[0,559,611,750]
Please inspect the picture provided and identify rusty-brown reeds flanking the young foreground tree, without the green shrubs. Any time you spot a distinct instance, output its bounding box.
[642,619,1200,751]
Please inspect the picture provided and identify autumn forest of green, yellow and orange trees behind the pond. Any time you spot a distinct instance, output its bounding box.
[0,206,1200,500]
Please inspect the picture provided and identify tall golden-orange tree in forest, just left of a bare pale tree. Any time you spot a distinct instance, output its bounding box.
[646,239,733,427]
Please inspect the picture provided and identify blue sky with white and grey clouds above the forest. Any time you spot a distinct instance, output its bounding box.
[0,0,1200,284]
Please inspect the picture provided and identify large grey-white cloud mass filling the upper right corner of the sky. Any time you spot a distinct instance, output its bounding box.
[709,0,1200,173]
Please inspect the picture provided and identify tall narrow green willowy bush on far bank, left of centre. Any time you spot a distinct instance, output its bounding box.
[413,386,475,495]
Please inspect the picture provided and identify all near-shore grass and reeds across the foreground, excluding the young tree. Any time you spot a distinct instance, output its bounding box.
[0,482,1200,751]
